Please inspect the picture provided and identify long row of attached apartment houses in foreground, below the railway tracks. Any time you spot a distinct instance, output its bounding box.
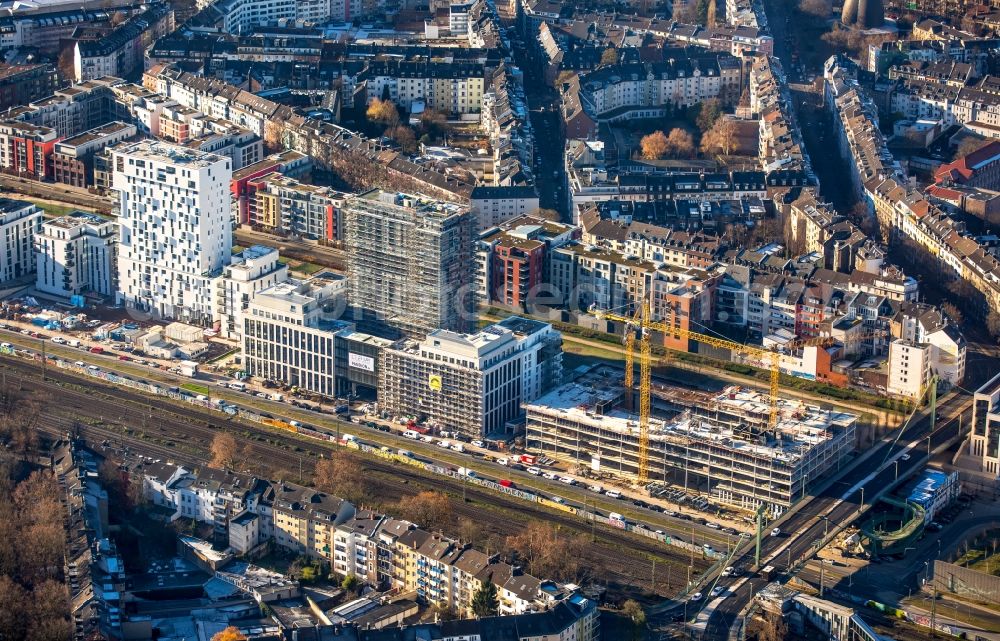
[130,463,599,624]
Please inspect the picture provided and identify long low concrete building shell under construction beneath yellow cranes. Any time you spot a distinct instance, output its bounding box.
[525,366,857,516]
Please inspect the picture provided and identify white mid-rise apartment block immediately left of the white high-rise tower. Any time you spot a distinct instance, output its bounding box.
[35,212,118,298]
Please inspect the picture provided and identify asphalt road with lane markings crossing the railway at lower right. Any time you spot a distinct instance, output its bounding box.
[705,394,971,640]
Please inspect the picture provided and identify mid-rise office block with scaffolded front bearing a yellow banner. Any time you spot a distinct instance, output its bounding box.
[378,316,562,438]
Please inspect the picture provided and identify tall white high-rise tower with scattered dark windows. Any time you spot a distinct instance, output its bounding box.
[112,140,233,323]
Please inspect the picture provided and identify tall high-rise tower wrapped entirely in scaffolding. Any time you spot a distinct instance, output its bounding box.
[344,190,476,338]
